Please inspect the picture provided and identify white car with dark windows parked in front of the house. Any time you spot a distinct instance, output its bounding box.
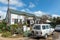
[32,24,54,38]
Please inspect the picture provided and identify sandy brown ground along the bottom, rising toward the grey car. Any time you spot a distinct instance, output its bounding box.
[0,32,60,40]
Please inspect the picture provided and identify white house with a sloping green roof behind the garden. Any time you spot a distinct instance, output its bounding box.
[6,9,35,25]
